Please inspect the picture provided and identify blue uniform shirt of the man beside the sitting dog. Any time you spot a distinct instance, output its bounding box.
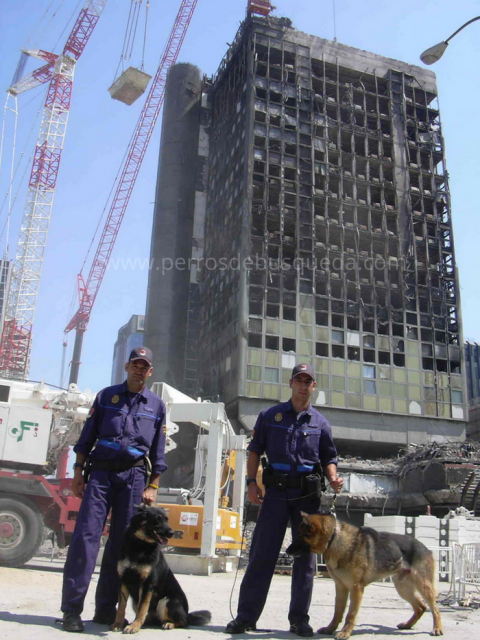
[73,382,167,473]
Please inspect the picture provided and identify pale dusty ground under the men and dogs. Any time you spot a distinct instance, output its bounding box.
[0,558,480,640]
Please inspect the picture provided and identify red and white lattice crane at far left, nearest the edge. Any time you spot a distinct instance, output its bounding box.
[0,0,107,380]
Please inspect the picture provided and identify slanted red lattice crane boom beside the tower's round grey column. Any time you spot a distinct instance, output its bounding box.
[65,0,197,383]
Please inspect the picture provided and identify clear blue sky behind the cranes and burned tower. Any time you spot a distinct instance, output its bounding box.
[0,0,480,391]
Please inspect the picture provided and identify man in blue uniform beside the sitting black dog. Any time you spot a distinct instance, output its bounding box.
[61,347,167,632]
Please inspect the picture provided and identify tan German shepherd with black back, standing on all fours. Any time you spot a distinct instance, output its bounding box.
[287,513,443,640]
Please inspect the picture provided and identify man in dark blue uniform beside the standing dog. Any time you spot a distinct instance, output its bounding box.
[225,364,343,637]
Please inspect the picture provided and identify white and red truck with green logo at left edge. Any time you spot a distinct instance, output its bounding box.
[0,379,95,567]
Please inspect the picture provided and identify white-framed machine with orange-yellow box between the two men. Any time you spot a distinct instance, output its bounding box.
[152,382,246,575]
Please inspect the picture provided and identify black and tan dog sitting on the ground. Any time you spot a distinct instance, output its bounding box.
[110,506,212,633]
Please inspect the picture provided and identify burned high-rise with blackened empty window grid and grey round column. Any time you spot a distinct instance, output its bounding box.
[145,10,466,453]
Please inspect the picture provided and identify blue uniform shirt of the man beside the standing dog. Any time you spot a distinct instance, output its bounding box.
[247,400,337,476]
